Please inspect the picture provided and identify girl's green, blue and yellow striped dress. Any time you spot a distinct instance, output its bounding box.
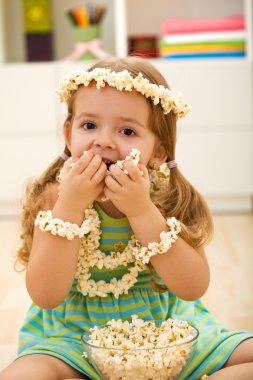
[18,205,253,380]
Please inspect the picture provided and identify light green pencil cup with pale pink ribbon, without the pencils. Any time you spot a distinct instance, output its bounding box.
[72,24,101,60]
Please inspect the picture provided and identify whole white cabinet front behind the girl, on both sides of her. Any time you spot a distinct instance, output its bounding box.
[0,60,253,214]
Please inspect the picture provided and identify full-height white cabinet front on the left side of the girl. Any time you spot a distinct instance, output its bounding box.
[0,64,60,215]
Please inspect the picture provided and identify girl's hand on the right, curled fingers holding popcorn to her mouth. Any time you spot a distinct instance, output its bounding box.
[104,160,153,217]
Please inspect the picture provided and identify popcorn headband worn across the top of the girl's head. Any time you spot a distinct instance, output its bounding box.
[56,67,191,118]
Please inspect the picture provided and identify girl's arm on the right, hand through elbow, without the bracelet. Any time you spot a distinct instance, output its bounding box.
[105,161,210,300]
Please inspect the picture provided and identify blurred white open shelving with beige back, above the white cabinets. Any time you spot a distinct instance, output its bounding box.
[0,0,252,62]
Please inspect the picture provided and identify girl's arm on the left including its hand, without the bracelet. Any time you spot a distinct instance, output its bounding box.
[26,151,107,309]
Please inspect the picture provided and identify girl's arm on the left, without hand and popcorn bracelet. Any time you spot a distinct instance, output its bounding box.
[26,184,83,309]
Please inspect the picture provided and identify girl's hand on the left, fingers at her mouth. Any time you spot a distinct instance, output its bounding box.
[56,150,107,215]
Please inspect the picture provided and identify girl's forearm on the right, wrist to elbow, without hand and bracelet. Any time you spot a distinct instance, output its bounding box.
[128,203,210,301]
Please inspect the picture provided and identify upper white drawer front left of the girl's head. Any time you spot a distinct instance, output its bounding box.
[0,64,56,135]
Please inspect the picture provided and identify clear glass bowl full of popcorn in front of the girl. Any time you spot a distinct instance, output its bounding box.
[82,315,199,380]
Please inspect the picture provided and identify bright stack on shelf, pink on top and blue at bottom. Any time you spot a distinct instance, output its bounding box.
[159,16,246,59]
